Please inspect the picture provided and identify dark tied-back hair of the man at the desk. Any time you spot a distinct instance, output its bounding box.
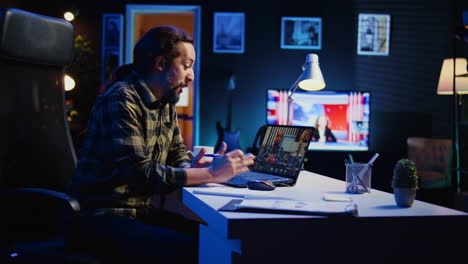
[133,26,193,74]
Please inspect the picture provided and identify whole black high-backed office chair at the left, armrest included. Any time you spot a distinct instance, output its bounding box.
[0,8,95,263]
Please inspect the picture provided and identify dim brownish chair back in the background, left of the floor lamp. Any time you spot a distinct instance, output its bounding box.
[407,137,452,189]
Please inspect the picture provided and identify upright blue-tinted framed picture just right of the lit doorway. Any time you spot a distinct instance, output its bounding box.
[213,12,245,53]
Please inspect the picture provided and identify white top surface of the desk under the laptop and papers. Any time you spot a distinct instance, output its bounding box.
[182,171,468,235]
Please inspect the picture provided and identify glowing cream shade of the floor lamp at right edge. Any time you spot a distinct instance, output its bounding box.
[437,58,468,95]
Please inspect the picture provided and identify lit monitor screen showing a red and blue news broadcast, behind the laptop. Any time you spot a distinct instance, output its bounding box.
[267,89,370,151]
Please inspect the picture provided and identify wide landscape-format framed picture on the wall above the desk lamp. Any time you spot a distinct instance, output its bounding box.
[281,17,322,49]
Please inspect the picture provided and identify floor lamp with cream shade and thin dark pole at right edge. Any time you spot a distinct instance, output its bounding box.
[437,58,468,192]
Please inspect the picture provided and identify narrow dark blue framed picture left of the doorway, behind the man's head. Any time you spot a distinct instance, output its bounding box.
[101,13,123,83]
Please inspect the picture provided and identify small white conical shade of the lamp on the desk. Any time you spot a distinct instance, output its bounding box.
[298,54,325,91]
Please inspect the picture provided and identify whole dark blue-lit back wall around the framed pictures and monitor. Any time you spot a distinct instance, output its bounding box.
[10,0,468,171]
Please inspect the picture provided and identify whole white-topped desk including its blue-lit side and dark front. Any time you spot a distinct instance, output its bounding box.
[182,171,468,263]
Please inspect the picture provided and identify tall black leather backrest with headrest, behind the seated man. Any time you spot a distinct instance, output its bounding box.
[0,8,76,191]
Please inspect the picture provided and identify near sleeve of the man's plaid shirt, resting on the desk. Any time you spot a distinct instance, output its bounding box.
[101,89,187,193]
